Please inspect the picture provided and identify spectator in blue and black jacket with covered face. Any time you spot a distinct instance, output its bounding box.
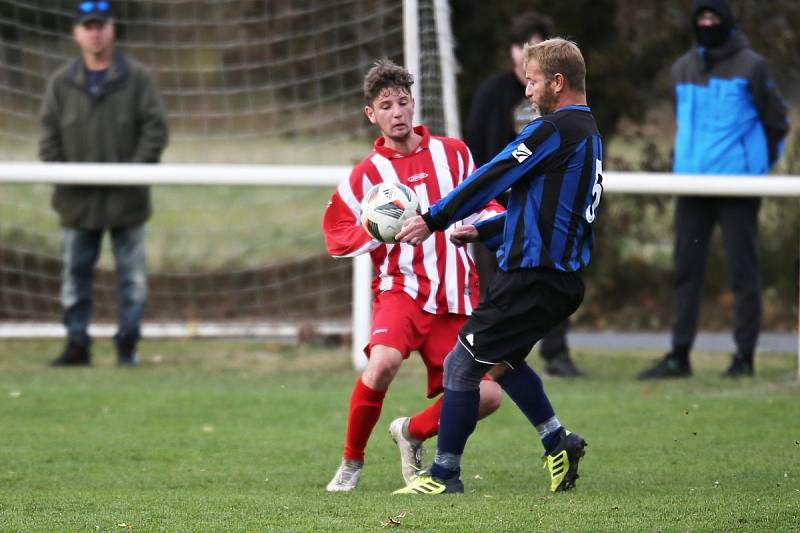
[639,0,789,379]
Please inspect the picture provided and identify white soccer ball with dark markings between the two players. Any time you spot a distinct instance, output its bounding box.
[361,183,419,244]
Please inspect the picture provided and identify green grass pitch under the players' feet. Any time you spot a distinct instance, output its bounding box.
[0,340,800,532]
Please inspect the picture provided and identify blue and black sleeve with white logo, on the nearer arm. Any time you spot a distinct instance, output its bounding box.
[422,120,561,231]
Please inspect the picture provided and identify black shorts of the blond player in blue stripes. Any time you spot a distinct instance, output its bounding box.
[458,268,584,367]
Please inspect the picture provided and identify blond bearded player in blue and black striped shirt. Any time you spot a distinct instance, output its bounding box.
[395,39,603,494]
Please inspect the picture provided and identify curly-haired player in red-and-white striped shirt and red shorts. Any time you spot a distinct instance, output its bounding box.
[322,60,503,492]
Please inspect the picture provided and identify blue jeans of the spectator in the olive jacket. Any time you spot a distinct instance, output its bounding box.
[61,224,147,347]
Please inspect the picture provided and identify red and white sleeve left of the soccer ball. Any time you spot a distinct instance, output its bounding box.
[322,165,381,257]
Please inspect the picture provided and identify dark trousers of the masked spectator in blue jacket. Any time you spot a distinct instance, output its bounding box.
[672,197,761,357]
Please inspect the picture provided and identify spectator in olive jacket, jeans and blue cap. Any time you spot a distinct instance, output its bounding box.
[39,1,168,366]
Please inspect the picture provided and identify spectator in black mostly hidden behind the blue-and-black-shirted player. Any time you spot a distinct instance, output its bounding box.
[464,11,583,377]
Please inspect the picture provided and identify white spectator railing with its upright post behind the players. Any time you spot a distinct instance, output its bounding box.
[0,163,800,377]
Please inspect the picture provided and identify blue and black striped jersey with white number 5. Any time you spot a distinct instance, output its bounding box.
[423,106,603,272]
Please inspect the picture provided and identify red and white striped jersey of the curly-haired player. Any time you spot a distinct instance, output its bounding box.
[322,126,503,315]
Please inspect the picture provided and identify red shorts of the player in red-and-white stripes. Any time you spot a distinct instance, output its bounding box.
[364,291,467,398]
